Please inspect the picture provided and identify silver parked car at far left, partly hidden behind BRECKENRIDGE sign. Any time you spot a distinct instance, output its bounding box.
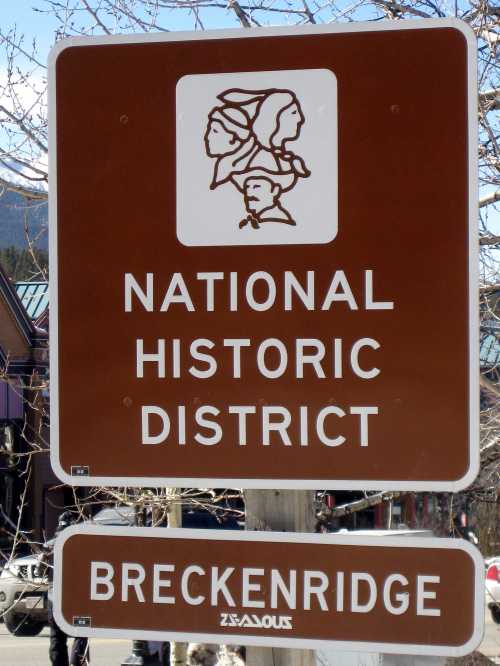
[0,507,134,636]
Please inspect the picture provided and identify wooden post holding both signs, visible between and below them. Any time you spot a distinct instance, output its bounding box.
[245,490,315,666]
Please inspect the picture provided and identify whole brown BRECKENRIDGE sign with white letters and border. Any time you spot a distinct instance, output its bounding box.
[54,526,484,656]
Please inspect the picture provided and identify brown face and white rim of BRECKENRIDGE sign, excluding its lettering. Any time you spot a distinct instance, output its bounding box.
[54,526,484,656]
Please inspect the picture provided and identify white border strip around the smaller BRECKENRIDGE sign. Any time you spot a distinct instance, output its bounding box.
[53,525,484,657]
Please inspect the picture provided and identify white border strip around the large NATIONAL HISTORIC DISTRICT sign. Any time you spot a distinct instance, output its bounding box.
[48,18,479,492]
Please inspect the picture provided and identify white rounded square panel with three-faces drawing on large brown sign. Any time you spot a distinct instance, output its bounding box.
[176,69,338,246]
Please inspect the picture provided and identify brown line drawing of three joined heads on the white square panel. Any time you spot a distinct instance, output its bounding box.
[204,88,311,229]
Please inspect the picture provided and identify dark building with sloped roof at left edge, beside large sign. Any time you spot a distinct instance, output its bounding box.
[0,268,51,554]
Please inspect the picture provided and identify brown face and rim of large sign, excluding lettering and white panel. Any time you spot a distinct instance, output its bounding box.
[51,22,477,490]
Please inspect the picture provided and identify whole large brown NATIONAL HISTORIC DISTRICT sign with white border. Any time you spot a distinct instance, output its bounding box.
[50,20,478,490]
